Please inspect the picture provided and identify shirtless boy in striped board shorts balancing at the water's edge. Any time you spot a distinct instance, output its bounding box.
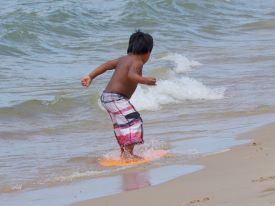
[81,30,156,160]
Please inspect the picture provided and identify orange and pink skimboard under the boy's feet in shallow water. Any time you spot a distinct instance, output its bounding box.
[98,150,168,167]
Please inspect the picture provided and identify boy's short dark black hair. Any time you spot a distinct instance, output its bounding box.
[127,30,154,54]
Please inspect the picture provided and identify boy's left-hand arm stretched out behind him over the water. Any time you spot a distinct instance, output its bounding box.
[81,59,119,87]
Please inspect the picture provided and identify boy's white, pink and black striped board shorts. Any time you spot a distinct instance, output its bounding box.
[101,92,143,147]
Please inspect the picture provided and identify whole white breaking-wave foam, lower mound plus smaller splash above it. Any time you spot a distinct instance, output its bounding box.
[131,54,225,110]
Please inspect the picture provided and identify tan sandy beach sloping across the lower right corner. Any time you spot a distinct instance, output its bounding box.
[75,123,275,206]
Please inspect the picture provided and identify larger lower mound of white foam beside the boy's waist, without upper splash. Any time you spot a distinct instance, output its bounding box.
[131,77,224,110]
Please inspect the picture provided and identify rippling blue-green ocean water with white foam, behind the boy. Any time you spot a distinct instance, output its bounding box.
[0,0,275,203]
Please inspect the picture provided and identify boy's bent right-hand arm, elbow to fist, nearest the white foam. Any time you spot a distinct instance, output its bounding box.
[128,64,157,85]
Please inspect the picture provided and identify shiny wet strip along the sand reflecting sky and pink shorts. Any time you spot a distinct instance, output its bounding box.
[1,165,203,206]
